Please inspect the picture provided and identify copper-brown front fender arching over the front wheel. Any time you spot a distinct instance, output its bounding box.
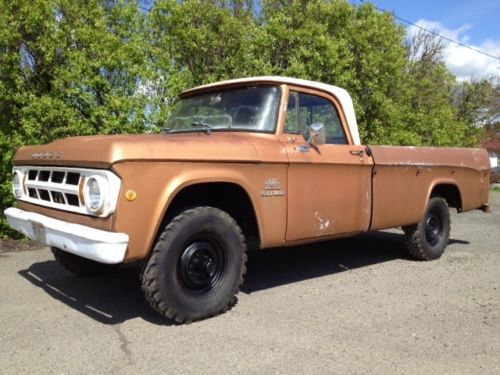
[113,161,286,261]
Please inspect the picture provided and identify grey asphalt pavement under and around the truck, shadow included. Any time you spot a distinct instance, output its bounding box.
[0,193,500,374]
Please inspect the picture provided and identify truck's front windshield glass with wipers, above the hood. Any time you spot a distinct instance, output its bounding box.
[165,86,281,133]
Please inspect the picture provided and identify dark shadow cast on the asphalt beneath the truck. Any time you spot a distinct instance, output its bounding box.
[19,232,461,325]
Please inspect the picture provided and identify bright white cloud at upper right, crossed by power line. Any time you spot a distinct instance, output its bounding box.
[408,19,500,81]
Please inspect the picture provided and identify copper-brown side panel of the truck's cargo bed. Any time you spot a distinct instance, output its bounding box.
[371,146,489,230]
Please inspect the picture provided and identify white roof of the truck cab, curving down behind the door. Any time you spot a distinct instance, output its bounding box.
[185,76,361,145]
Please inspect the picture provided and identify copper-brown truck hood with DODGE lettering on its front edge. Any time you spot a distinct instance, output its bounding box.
[14,132,278,168]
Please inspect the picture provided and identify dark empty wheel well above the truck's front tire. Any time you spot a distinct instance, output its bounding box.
[159,182,260,247]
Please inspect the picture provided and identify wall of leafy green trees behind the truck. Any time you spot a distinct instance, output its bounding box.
[0,0,498,235]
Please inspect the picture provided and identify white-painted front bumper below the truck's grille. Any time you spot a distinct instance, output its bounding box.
[4,207,128,264]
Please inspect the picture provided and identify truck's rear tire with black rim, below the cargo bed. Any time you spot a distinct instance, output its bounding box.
[403,197,451,260]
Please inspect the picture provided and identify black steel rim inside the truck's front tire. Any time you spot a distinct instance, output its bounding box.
[177,239,225,294]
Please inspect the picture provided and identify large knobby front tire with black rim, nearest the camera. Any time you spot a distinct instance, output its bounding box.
[141,207,247,323]
